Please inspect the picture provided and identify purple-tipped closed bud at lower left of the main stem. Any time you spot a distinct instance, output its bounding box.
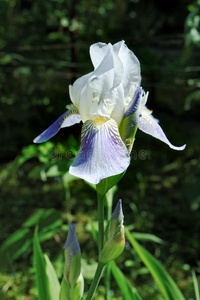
[63,223,84,300]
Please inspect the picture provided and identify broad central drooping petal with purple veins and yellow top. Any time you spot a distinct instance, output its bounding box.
[69,118,130,184]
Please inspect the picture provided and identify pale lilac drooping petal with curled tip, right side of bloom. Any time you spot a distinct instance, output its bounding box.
[138,108,186,150]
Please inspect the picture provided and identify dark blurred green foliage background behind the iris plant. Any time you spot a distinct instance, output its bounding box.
[0,0,200,300]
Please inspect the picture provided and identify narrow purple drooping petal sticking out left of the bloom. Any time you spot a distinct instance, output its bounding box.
[33,105,81,144]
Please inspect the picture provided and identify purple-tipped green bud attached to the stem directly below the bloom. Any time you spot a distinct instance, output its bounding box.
[99,200,125,264]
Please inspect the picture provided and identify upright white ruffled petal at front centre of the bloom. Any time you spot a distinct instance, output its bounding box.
[90,44,124,123]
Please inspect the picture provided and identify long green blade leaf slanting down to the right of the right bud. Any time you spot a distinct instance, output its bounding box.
[125,229,185,300]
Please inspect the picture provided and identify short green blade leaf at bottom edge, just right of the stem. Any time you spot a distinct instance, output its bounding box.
[109,261,142,300]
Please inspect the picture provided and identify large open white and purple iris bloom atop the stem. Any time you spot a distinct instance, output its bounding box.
[34,41,185,184]
